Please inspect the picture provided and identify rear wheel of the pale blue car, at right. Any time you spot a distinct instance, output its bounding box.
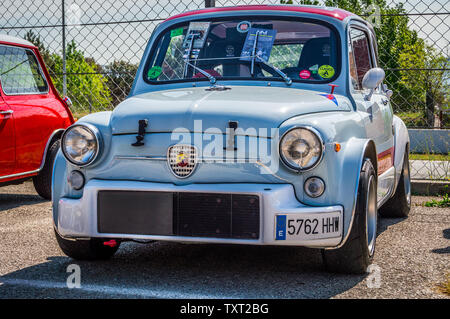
[380,149,411,218]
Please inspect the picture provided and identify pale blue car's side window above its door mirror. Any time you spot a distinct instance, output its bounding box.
[349,28,372,90]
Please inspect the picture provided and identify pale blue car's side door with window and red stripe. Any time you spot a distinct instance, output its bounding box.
[348,25,394,202]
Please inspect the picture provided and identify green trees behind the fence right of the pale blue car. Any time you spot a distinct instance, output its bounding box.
[283,0,448,125]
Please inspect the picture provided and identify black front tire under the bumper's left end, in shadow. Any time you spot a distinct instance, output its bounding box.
[55,230,120,260]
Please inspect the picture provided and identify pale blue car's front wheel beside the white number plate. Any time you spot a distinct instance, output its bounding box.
[322,159,377,274]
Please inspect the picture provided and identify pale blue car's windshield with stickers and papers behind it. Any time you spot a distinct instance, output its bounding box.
[144,17,339,83]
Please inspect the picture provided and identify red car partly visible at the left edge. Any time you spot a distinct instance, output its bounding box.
[0,34,74,199]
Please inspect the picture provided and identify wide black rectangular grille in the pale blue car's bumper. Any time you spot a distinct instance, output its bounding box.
[97,191,260,239]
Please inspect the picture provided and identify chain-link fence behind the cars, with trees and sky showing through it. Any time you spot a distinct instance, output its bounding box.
[0,0,450,180]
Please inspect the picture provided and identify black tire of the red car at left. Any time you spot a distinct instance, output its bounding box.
[33,140,61,200]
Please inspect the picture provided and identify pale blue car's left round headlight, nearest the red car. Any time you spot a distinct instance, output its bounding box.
[61,124,100,166]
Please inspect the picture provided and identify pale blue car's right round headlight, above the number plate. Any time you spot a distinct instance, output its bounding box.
[280,127,323,171]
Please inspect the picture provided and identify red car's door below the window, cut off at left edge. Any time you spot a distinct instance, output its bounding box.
[0,91,15,178]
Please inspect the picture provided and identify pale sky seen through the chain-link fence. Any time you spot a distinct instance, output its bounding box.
[0,0,450,65]
